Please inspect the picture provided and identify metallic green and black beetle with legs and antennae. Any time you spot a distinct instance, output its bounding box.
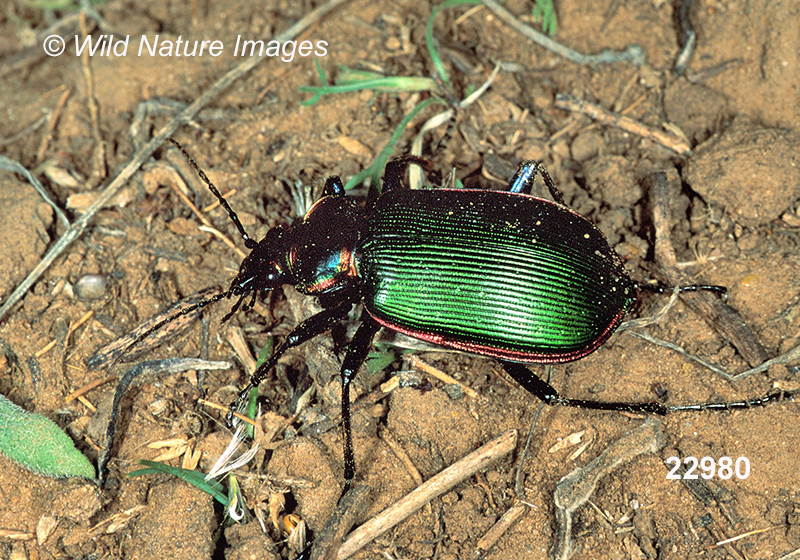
[123,139,794,491]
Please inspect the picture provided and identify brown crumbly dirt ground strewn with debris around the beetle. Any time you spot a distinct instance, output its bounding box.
[0,0,800,560]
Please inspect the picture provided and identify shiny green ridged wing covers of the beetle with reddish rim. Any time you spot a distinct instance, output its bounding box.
[360,188,636,363]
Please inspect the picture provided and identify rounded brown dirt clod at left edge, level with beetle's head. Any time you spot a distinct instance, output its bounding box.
[0,173,53,299]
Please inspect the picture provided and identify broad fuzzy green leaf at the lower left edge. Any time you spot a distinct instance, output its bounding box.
[0,395,96,479]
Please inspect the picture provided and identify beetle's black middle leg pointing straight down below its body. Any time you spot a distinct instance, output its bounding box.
[342,310,381,494]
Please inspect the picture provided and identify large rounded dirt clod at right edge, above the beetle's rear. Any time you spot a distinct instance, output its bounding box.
[685,117,800,227]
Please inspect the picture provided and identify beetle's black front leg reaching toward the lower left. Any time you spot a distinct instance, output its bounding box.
[226,290,361,425]
